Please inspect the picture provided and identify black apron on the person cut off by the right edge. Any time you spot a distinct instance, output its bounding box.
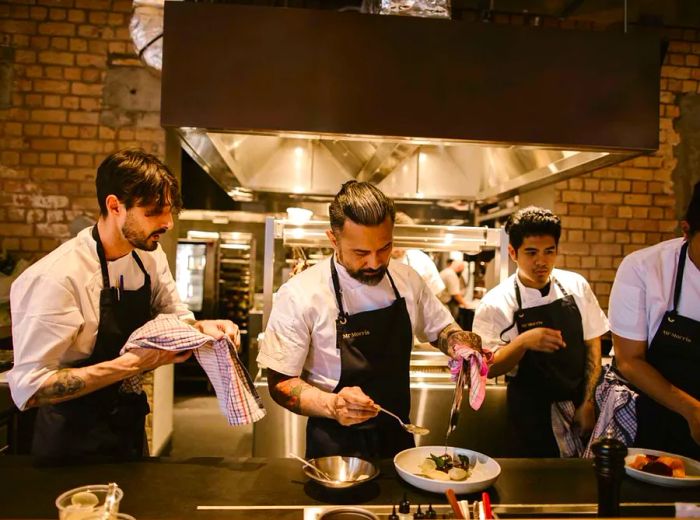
[635,242,700,459]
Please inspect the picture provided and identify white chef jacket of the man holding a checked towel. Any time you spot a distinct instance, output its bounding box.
[7,226,194,409]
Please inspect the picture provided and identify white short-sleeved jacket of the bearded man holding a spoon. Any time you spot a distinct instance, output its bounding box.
[257,258,454,391]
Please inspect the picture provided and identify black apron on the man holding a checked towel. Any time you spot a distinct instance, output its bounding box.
[32,225,152,462]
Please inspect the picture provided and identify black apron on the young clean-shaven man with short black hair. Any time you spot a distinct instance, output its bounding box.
[501,275,586,457]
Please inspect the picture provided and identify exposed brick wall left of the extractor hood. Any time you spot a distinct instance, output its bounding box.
[0,0,164,257]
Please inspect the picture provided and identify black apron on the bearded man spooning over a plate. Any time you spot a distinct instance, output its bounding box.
[306,259,415,458]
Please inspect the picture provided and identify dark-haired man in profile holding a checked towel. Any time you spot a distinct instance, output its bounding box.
[8,150,238,460]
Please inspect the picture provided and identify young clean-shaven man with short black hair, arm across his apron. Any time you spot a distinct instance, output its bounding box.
[473,207,608,457]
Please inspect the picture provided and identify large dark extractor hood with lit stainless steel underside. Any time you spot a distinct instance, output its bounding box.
[161,2,660,202]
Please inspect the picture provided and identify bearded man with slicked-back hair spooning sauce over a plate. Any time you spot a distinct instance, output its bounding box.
[257,181,480,458]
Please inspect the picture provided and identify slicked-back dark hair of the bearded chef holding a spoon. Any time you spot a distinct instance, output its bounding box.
[328,181,396,231]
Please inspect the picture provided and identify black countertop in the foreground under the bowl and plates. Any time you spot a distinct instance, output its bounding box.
[0,456,700,520]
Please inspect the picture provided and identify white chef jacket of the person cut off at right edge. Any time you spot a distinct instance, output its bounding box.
[608,238,700,343]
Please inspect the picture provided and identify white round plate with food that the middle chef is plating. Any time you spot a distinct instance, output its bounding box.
[394,446,501,495]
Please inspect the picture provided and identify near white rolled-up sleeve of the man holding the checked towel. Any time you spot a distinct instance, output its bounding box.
[7,276,84,410]
